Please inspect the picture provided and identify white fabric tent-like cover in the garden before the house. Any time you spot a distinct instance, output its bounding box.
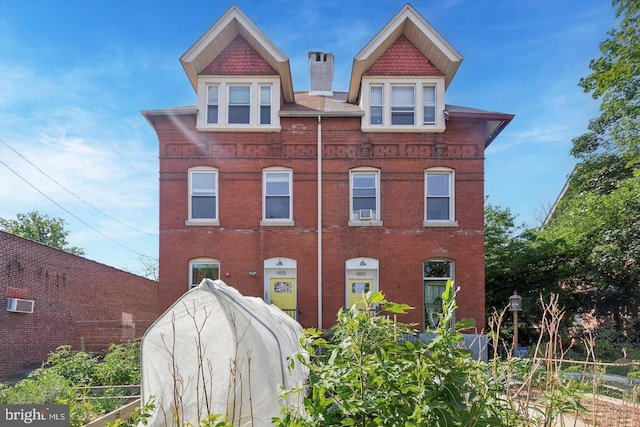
[141,279,307,427]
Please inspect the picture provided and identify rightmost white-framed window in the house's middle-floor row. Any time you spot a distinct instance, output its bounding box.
[425,168,456,226]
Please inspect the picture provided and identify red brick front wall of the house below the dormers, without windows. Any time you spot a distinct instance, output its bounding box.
[154,111,485,328]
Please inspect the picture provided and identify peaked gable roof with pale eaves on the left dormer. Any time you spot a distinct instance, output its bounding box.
[180,5,294,102]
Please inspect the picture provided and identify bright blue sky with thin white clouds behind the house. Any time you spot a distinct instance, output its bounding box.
[0,0,615,272]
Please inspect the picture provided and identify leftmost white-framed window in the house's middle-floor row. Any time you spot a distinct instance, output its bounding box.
[187,166,218,225]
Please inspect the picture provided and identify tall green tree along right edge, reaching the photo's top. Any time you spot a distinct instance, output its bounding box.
[538,0,640,331]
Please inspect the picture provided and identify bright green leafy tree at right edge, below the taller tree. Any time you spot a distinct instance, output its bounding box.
[540,171,640,331]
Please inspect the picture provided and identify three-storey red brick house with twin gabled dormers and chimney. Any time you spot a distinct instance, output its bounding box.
[142,5,513,328]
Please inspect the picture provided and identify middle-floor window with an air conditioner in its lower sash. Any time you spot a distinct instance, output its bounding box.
[350,168,381,225]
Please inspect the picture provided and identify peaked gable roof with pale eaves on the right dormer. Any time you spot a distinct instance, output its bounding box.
[347,4,462,103]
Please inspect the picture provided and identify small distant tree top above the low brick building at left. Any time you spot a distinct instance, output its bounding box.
[0,211,84,255]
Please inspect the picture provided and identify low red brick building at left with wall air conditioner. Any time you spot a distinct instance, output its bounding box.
[0,231,159,380]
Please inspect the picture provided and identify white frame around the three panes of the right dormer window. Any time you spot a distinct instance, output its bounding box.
[360,77,446,133]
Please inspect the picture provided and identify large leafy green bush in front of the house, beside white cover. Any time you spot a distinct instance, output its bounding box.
[274,282,505,427]
